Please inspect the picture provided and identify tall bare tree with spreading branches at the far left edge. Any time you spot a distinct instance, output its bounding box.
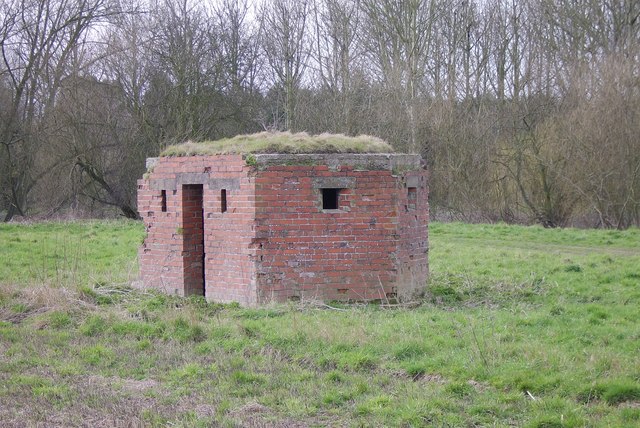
[0,0,116,221]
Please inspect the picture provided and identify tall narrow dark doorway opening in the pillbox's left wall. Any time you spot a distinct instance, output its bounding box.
[179,184,206,296]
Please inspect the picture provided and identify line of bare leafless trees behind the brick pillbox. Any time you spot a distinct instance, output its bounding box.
[0,0,640,228]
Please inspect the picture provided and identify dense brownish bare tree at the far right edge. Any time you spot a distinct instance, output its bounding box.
[551,53,640,229]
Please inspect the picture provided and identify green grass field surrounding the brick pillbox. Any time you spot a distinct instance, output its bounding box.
[0,222,640,427]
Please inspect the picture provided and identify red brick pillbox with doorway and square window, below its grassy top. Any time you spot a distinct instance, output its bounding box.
[138,134,429,306]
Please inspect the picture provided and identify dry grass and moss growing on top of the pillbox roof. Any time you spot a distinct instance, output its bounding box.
[160,132,394,156]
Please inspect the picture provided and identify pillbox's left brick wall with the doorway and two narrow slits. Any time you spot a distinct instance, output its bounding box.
[138,156,256,304]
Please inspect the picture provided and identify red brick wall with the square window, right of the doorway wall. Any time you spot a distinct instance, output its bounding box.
[256,165,427,301]
